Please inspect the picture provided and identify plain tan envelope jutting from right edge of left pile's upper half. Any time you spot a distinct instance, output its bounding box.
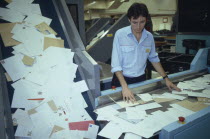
[44,37,64,50]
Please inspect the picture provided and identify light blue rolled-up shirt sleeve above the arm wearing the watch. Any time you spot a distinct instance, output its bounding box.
[148,37,160,63]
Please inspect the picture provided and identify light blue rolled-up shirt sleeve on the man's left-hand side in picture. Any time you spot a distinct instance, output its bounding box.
[111,32,122,73]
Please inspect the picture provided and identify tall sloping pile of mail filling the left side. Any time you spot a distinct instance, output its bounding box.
[0,0,98,139]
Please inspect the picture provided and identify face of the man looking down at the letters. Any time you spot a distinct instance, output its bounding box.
[129,16,146,33]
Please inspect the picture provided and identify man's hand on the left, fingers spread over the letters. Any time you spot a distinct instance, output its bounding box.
[122,87,136,103]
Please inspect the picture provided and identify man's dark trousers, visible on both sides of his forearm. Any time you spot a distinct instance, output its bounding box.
[111,73,146,87]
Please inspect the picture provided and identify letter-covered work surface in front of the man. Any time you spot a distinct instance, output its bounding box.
[96,72,210,138]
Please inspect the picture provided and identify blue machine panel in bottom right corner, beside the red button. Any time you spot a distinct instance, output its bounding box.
[159,107,210,139]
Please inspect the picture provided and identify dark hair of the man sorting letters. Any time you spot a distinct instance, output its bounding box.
[127,3,149,19]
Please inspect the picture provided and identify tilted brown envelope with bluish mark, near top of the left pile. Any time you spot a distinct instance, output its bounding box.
[35,22,57,35]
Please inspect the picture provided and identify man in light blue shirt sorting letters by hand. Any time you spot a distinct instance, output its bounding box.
[111,3,181,102]
